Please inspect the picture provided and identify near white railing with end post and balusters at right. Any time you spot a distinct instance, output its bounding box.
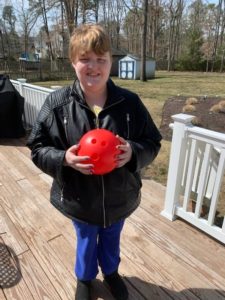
[161,114,225,243]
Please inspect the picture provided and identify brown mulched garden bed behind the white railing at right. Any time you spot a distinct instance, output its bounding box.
[160,96,225,141]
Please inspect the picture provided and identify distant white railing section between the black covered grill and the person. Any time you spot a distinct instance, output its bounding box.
[11,80,53,129]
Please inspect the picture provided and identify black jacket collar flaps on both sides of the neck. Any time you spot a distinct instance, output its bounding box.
[71,79,122,107]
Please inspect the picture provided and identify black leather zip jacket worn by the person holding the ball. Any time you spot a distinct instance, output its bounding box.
[27,80,161,226]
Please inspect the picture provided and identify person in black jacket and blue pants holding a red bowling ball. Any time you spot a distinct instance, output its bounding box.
[28,25,161,300]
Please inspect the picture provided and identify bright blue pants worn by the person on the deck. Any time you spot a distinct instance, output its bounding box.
[73,220,124,280]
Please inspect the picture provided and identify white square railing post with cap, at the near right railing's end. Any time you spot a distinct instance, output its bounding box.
[161,114,194,221]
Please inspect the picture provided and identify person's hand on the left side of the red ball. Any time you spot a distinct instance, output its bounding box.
[63,145,94,175]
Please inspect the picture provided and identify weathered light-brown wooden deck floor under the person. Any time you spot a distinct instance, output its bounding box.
[0,140,225,300]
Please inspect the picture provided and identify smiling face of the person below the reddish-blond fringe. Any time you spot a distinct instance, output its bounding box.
[73,51,112,93]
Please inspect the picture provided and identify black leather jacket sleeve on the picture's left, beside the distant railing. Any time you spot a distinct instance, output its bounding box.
[27,94,65,182]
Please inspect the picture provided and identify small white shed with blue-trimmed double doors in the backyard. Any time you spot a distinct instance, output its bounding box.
[119,55,155,79]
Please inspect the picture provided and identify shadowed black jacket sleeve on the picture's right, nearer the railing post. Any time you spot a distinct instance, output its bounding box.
[128,99,162,172]
